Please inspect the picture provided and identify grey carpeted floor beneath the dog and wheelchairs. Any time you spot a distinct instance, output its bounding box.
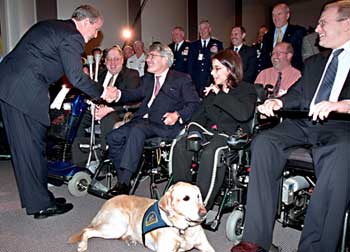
[0,161,300,252]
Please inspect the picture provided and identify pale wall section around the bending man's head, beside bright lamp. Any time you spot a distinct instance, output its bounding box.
[57,0,128,53]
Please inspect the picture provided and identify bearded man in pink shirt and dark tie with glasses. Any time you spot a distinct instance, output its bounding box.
[255,42,301,97]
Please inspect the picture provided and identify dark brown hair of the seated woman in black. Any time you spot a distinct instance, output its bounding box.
[212,49,243,88]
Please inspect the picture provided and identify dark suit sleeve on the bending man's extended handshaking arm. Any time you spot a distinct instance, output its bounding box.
[58,34,103,99]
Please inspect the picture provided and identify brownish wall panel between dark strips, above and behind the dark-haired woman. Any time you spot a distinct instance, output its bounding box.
[198,0,234,48]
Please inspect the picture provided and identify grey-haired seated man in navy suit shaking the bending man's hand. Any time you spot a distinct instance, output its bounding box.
[107,44,199,195]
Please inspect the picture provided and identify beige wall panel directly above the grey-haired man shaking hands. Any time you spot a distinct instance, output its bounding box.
[141,0,187,49]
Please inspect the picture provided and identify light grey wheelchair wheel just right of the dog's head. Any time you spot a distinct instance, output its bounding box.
[226,210,243,245]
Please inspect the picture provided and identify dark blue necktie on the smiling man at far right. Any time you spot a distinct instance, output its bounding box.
[315,48,344,104]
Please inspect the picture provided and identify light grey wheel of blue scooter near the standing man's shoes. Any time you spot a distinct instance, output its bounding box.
[68,171,91,197]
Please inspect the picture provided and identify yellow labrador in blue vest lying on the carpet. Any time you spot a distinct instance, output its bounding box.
[69,182,215,252]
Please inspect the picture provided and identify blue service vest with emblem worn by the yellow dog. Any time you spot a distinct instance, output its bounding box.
[142,201,170,246]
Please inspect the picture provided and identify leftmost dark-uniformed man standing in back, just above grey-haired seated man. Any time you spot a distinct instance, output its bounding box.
[169,26,190,73]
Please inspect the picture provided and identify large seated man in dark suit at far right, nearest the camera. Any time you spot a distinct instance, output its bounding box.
[231,1,350,252]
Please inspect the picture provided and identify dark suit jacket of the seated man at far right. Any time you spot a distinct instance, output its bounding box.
[281,51,350,110]
